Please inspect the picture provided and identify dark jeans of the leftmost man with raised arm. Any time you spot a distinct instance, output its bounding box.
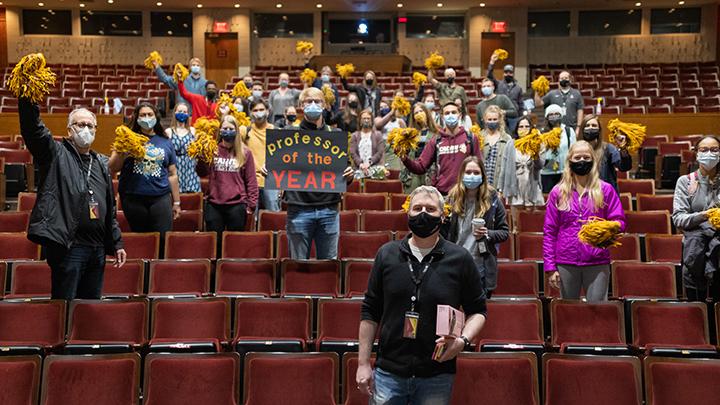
[45,245,105,300]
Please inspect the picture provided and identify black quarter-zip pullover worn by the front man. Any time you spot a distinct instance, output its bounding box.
[362,236,486,378]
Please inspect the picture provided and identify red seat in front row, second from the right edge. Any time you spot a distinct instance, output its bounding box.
[543,353,642,405]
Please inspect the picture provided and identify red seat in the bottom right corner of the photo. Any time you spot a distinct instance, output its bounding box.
[643,357,720,405]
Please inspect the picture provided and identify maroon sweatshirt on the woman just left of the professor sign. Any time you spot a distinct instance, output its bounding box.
[197,142,258,210]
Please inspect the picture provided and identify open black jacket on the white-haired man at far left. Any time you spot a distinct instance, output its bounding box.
[18,98,123,256]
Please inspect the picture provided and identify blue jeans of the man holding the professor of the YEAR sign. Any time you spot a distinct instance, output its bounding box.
[287,205,340,260]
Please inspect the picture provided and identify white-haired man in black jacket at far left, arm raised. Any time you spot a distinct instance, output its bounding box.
[18,98,126,300]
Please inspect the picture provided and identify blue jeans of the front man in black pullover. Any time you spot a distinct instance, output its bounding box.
[370,368,455,405]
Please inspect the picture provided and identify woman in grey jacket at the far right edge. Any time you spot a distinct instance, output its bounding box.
[672,136,720,302]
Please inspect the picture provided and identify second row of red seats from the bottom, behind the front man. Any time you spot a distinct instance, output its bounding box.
[0,297,720,358]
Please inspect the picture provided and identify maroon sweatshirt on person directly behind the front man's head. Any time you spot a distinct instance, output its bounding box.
[402,128,483,195]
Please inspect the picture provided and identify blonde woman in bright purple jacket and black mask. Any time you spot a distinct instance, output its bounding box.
[543,141,625,302]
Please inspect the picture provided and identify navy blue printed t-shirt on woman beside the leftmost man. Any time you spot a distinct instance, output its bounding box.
[118,135,176,197]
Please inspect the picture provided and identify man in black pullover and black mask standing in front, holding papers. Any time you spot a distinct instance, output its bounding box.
[356,186,486,405]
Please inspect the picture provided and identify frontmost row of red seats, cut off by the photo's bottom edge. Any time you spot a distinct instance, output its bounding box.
[0,353,720,405]
